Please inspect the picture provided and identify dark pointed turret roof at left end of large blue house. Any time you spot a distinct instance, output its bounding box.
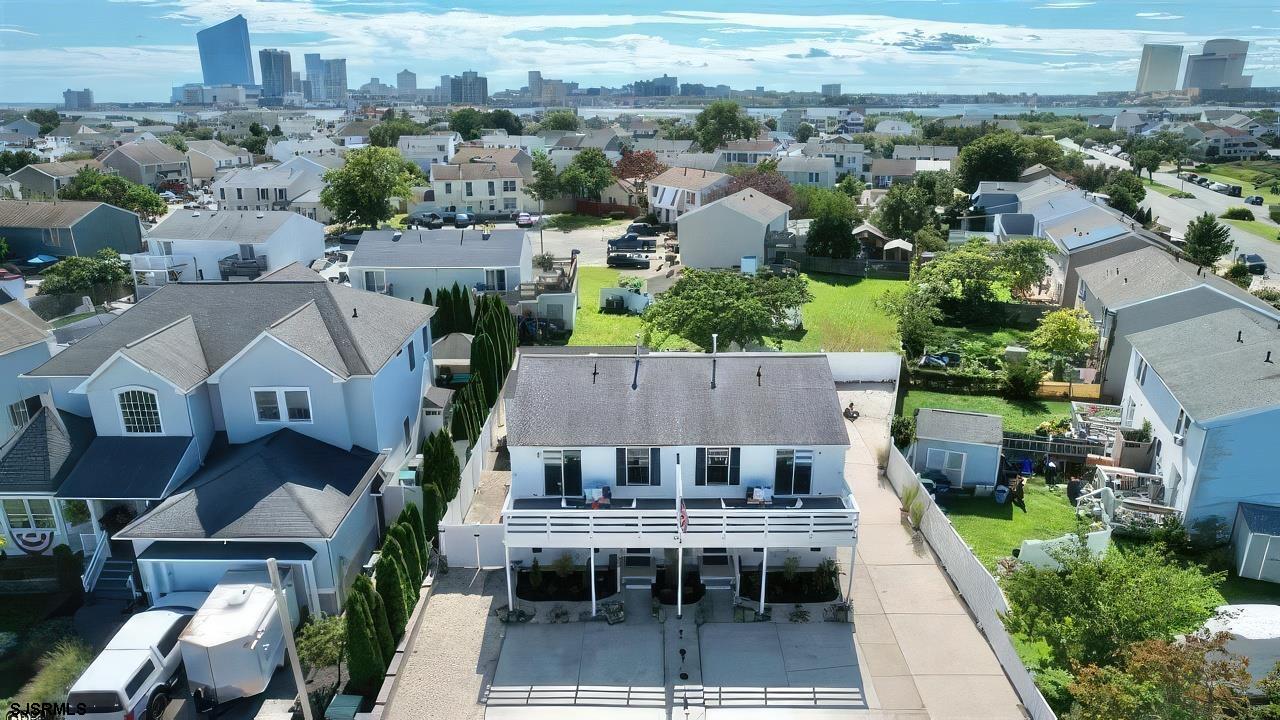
[0,407,93,492]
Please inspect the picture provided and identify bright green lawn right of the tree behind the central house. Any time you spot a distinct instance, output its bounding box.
[782,273,904,352]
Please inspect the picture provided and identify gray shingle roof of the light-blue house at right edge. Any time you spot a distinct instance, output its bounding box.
[1126,309,1280,423]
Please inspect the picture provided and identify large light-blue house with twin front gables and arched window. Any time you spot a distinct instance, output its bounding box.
[16,265,434,612]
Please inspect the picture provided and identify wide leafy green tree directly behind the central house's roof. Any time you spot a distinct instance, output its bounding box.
[643,268,813,348]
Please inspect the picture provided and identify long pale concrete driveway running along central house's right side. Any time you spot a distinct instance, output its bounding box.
[840,384,1025,720]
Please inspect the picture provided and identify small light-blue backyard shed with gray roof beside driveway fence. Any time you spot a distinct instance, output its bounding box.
[911,407,1005,489]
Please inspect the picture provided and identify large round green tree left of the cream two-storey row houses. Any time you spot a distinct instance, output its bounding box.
[320,147,415,227]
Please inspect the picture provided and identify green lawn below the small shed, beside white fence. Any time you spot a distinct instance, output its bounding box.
[938,478,1075,570]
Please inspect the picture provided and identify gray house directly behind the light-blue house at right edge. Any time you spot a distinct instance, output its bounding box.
[1075,246,1280,400]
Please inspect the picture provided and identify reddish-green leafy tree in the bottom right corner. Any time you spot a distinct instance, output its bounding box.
[1068,633,1251,720]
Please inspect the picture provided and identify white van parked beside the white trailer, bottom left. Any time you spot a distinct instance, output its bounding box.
[67,609,192,720]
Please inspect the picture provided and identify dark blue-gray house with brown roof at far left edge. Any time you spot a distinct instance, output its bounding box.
[0,200,142,260]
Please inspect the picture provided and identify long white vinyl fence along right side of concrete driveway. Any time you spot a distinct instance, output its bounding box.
[887,447,1057,720]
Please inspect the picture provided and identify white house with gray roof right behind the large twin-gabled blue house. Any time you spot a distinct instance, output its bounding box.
[131,210,324,297]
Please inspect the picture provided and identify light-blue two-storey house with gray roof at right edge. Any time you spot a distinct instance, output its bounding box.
[1121,309,1280,530]
